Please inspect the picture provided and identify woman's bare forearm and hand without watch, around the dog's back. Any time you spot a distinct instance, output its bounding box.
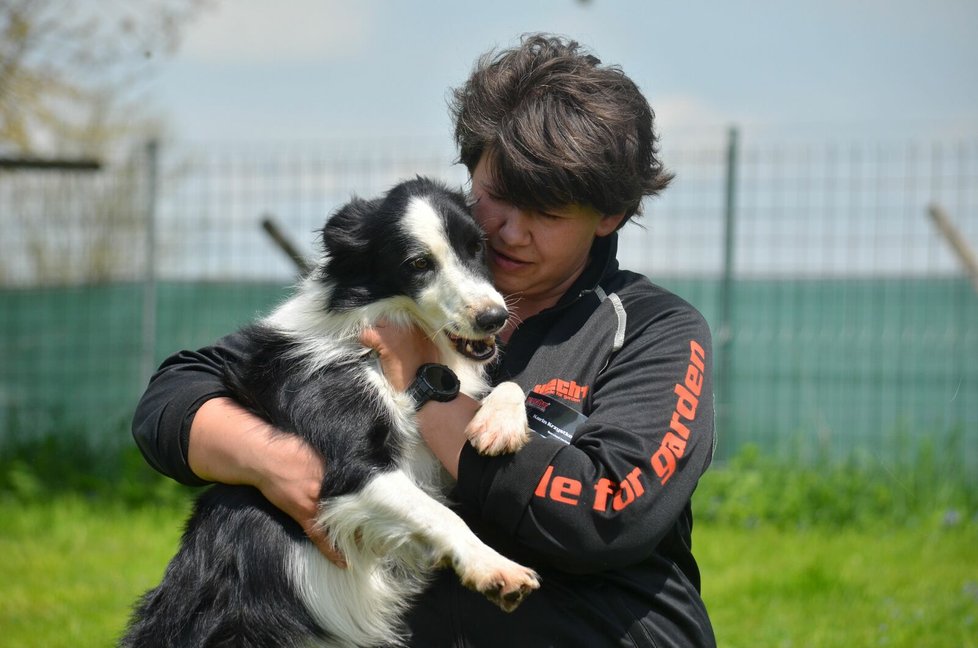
[187,398,346,567]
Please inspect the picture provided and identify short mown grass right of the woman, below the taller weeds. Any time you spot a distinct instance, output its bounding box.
[696,524,978,648]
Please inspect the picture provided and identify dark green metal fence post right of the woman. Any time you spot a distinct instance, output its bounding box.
[714,126,739,454]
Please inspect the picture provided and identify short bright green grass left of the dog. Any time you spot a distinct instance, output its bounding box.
[0,495,186,648]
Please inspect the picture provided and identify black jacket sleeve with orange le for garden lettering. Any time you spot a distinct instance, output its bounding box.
[457,299,714,573]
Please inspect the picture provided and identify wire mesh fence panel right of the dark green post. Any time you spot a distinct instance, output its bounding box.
[723,139,978,468]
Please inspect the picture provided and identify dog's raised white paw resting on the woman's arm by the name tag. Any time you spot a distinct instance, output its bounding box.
[465,382,530,455]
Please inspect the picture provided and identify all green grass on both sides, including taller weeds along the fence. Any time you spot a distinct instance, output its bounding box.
[0,438,978,648]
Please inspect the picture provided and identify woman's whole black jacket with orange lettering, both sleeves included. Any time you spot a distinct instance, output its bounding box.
[133,235,716,648]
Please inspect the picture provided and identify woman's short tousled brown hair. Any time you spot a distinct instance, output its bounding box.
[451,34,672,223]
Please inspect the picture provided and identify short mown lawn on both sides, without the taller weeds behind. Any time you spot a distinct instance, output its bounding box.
[0,495,978,648]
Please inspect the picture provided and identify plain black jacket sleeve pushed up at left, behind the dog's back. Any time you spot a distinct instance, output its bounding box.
[132,334,250,486]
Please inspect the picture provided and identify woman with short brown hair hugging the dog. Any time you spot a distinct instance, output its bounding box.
[133,35,716,648]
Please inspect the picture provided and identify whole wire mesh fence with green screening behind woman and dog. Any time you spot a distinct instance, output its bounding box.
[0,132,978,474]
